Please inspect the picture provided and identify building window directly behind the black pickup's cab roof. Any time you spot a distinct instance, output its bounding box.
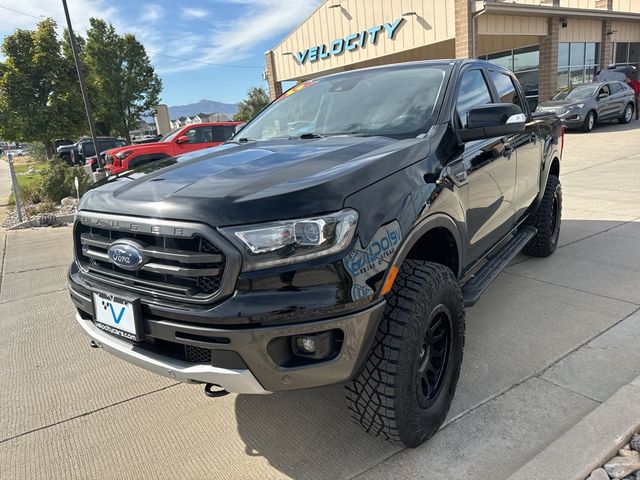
[480,45,540,111]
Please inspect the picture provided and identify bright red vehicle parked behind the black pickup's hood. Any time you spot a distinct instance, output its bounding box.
[104,122,242,175]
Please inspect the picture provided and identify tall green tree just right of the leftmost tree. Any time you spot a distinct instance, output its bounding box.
[84,18,162,141]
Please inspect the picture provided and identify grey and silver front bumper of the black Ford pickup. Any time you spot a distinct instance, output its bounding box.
[70,285,385,393]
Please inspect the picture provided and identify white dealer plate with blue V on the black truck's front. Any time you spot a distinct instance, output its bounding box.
[93,293,141,342]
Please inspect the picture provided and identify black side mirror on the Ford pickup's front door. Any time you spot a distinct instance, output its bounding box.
[458,103,527,142]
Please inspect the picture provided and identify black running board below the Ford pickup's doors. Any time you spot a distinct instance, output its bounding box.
[462,227,538,307]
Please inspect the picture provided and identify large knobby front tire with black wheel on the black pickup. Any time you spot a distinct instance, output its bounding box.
[346,260,464,447]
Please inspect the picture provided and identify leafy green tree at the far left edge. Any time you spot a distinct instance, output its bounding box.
[0,19,84,152]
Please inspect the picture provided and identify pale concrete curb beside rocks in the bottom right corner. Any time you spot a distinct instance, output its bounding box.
[508,377,640,480]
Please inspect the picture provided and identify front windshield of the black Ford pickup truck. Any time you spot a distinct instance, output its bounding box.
[234,66,448,140]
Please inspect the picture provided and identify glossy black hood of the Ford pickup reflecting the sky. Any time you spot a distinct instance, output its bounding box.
[79,137,431,226]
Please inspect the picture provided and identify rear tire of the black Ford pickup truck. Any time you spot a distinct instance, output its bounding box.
[522,175,562,257]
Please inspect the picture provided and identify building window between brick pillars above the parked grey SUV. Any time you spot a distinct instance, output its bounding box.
[558,42,600,89]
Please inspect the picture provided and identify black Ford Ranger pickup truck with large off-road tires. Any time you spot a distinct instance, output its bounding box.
[69,60,564,447]
